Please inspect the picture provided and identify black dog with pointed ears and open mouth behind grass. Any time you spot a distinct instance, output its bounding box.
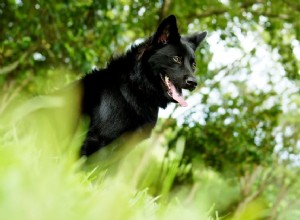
[81,15,206,156]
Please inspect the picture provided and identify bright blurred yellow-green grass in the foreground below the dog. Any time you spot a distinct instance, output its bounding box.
[0,86,264,220]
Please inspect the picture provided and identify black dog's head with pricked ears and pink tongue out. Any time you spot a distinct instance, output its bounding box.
[148,15,207,106]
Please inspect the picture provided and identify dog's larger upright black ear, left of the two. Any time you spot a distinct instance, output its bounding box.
[153,15,180,44]
